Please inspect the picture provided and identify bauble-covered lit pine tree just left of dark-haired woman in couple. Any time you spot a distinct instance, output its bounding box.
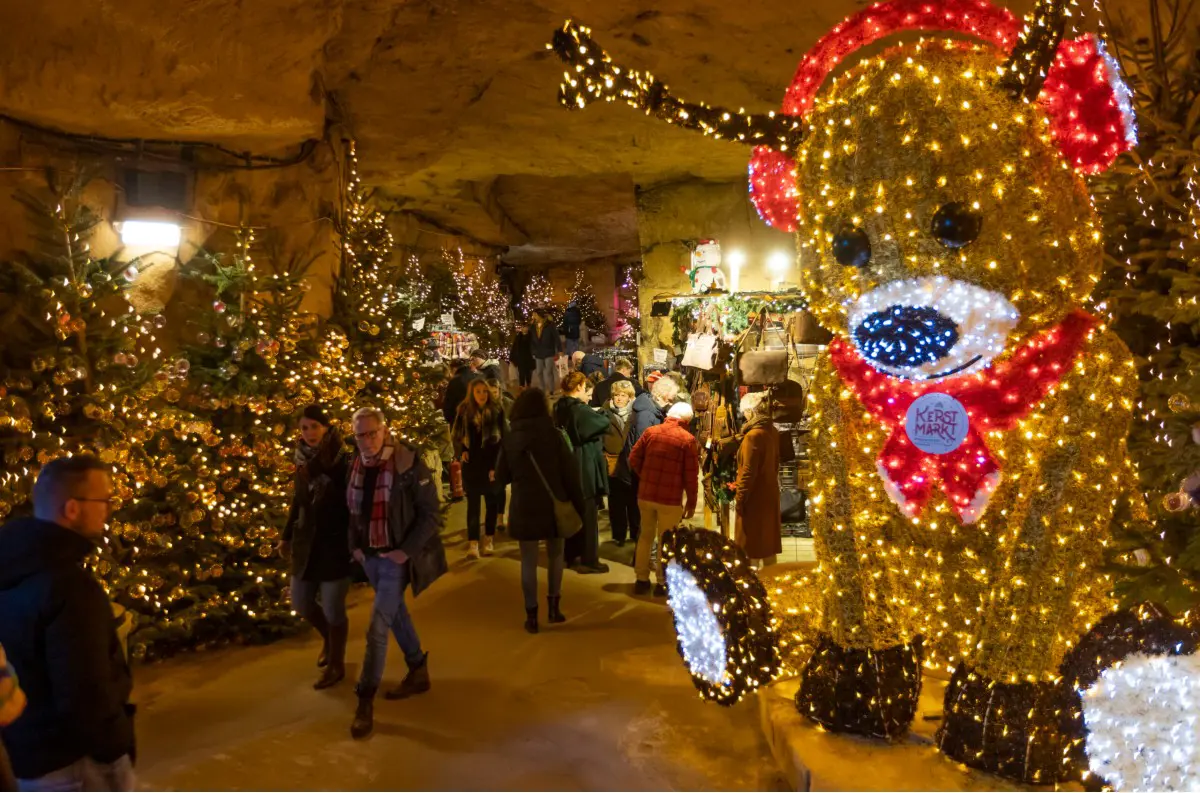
[108,232,314,657]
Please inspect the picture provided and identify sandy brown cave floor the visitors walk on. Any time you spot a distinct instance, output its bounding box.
[134,503,786,791]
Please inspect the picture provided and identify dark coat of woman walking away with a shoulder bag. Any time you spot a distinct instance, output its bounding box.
[496,416,583,540]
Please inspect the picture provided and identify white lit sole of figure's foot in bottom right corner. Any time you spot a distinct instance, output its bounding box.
[1082,654,1200,791]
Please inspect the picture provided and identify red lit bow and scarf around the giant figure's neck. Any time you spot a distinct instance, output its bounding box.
[829,311,1096,523]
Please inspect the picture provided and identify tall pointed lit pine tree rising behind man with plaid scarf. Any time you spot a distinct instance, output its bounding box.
[319,143,442,449]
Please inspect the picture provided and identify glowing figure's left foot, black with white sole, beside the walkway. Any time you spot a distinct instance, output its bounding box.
[661,529,779,705]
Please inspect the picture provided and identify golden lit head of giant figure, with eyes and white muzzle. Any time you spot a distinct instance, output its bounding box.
[797,41,1102,379]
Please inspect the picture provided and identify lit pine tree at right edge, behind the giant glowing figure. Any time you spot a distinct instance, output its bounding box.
[1094,0,1200,614]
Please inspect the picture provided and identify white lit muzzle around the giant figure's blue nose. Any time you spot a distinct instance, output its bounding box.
[850,276,1020,380]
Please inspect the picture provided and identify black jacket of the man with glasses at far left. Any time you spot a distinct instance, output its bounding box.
[0,518,134,779]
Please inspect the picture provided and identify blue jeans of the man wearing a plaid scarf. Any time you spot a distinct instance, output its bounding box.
[359,557,425,693]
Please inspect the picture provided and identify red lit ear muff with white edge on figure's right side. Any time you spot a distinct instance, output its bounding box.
[1038,35,1138,174]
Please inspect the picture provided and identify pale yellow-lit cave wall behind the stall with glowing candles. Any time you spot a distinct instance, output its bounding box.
[637,180,797,365]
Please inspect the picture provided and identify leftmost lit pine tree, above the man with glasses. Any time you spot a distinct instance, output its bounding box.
[0,172,186,549]
